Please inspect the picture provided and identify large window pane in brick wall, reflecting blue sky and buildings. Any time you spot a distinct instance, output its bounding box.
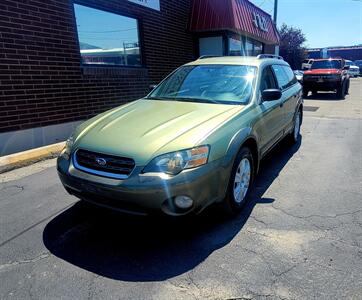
[74,4,141,66]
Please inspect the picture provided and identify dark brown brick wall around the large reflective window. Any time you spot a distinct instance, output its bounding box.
[0,0,194,132]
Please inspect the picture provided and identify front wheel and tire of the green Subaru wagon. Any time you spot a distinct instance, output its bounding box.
[222,147,255,216]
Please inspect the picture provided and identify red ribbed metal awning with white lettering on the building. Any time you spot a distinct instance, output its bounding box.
[190,0,279,44]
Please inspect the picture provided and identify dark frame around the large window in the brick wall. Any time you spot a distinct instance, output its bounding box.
[70,0,146,70]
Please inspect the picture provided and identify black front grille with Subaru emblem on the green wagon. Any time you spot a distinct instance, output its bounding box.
[74,149,135,178]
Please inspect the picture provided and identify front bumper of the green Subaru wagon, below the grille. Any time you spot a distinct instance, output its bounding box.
[57,156,230,216]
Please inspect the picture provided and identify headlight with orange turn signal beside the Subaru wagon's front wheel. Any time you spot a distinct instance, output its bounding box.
[143,146,210,175]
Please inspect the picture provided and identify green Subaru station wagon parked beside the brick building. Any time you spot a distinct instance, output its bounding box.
[57,55,303,216]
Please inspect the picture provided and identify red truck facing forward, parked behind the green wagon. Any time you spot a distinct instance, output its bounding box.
[303,58,349,99]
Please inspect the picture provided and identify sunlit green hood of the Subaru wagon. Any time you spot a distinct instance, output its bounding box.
[74,99,244,165]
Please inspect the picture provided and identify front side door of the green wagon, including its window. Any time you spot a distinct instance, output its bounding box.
[255,66,284,155]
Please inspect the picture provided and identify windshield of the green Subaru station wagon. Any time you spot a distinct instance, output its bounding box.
[147,65,256,104]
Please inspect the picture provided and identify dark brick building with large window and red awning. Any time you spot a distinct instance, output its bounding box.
[0,0,279,156]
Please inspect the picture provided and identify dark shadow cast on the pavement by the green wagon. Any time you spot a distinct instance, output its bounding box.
[43,137,300,282]
